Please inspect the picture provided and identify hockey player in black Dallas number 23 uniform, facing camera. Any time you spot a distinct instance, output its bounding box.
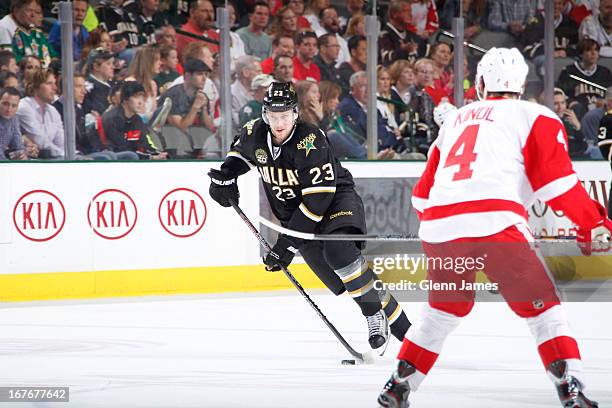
[208,82,410,349]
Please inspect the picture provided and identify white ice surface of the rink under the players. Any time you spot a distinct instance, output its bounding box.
[0,291,612,408]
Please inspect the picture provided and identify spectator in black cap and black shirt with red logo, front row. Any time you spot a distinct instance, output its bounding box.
[100,81,168,160]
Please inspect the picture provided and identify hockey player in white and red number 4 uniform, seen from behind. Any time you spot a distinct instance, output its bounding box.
[378,48,612,408]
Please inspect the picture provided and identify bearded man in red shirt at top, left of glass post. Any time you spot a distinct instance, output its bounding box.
[176,0,219,59]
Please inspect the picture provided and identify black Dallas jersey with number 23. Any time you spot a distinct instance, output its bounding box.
[221,119,365,232]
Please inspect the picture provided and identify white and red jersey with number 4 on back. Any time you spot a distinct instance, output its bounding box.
[412,98,599,242]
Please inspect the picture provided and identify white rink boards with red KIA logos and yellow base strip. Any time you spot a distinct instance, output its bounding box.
[0,162,610,301]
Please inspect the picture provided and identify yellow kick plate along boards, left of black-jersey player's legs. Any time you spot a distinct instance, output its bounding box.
[0,264,324,302]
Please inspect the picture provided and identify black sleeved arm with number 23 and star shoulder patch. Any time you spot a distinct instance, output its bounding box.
[289,130,337,232]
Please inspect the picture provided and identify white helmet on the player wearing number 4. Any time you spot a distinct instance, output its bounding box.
[475,47,529,99]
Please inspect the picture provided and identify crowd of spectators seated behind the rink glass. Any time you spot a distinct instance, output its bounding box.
[0,0,612,160]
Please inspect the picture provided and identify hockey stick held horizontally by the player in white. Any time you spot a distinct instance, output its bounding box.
[259,216,576,242]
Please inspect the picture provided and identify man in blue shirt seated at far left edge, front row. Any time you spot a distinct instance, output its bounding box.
[0,88,27,161]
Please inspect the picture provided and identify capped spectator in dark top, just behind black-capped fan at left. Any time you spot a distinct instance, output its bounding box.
[83,48,115,116]
